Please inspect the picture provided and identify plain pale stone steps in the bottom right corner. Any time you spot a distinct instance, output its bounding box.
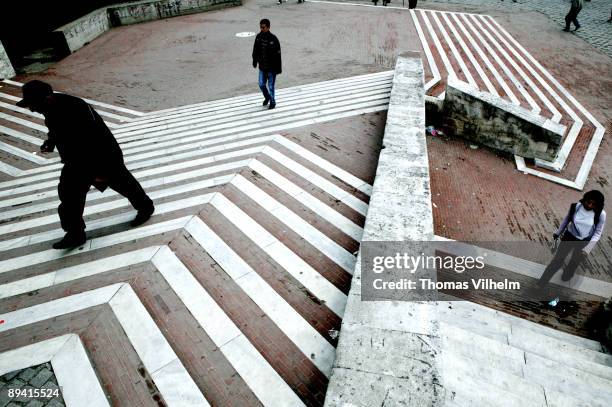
[437,301,612,407]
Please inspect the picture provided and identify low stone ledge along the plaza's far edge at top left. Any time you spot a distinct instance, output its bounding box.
[53,0,242,54]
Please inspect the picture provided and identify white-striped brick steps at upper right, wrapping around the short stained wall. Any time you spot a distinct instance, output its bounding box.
[410,9,605,189]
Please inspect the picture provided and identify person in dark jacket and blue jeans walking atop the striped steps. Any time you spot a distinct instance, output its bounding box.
[253,18,282,109]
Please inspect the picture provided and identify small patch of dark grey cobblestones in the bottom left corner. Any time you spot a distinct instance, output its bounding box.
[0,363,65,407]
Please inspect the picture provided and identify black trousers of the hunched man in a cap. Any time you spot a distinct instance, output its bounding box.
[57,164,153,233]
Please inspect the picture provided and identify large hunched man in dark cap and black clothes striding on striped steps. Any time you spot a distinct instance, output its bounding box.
[17,80,155,249]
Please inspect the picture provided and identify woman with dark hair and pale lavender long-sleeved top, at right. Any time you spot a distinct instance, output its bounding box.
[538,190,606,307]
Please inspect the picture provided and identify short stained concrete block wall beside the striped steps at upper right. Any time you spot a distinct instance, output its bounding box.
[443,77,565,161]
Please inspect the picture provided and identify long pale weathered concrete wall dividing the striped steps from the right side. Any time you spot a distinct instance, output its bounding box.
[325,52,444,407]
